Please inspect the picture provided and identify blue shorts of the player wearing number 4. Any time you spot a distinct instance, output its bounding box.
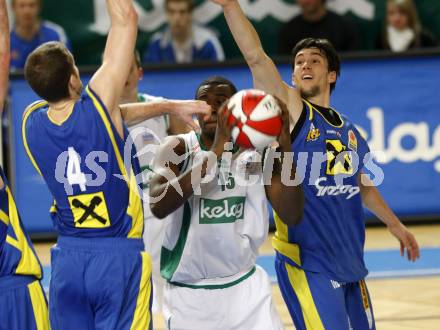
[49,237,152,330]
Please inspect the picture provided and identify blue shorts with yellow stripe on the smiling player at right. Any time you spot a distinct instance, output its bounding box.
[275,253,376,330]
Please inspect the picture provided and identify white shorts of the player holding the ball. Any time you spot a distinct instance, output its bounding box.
[163,266,283,330]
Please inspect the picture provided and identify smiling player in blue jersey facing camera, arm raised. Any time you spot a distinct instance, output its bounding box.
[212,0,419,330]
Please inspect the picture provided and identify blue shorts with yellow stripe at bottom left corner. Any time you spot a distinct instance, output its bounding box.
[0,275,49,330]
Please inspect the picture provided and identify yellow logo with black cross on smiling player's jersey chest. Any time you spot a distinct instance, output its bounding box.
[325,140,353,175]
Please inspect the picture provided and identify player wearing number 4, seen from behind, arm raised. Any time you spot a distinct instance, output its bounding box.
[23,0,209,330]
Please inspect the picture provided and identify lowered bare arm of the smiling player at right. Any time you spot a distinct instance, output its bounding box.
[358,174,420,261]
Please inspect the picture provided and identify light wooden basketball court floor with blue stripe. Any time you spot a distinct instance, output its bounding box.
[35,225,440,330]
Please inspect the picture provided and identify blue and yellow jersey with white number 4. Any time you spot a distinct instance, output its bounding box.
[22,86,143,238]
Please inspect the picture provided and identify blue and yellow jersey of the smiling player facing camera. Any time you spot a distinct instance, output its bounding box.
[273,101,369,282]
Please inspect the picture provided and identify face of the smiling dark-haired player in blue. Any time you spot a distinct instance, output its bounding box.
[292,48,336,98]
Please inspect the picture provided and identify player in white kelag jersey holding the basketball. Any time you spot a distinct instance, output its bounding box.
[150,77,302,330]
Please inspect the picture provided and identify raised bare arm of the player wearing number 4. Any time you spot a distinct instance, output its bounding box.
[89,0,137,116]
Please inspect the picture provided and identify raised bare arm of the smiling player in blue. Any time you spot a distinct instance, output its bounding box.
[212,0,302,123]
